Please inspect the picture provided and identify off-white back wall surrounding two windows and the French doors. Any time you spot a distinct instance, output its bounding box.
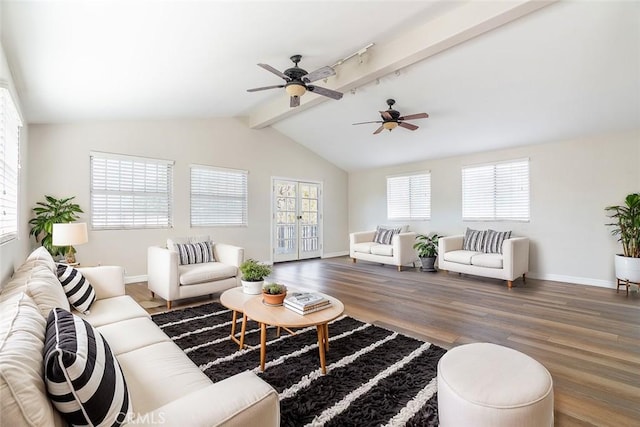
[27,118,348,279]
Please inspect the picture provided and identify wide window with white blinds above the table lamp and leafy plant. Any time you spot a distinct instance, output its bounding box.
[91,152,174,230]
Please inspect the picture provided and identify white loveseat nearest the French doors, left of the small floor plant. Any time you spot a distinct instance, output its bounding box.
[349,230,419,271]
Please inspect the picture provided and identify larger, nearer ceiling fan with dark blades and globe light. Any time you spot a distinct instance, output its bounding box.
[247,55,342,108]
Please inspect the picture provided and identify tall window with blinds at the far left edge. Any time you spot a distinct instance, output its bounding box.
[0,88,22,244]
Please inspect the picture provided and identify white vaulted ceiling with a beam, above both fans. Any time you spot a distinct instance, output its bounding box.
[0,0,640,170]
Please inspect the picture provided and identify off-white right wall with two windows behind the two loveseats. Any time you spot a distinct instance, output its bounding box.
[349,131,640,286]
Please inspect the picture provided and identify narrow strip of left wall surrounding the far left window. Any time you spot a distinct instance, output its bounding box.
[0,41,30,284]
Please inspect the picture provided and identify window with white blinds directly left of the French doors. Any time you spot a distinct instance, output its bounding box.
[191,165,248,227]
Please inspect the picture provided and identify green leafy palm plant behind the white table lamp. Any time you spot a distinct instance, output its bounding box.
[29,196,83,257]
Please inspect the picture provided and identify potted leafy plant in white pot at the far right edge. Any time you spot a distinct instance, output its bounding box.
[605,193,640,283]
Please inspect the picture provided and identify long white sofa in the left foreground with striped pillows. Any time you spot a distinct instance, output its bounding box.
[0,248,280,427]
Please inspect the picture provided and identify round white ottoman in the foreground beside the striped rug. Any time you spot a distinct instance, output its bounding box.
[438,343,553,427]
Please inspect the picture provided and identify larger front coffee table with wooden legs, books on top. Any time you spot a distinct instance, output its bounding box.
[244,289,344,374]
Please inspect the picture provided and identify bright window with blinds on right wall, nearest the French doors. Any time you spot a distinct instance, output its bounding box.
[387,172,431,220]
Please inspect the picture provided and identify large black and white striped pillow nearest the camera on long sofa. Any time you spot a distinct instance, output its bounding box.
[44,308,133,426]
